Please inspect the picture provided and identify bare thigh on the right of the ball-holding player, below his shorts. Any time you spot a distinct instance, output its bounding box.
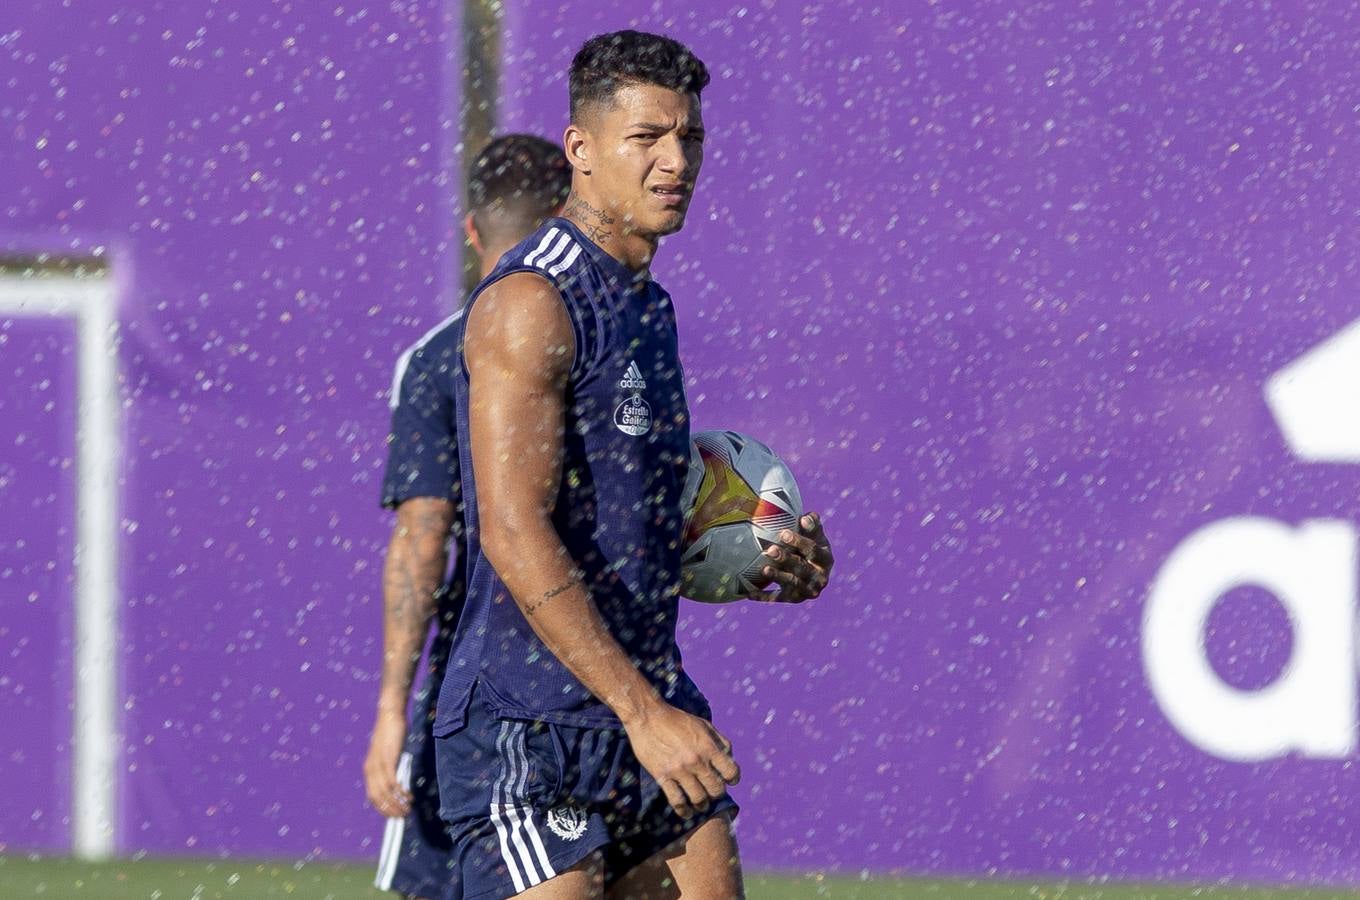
[607,813,745,900]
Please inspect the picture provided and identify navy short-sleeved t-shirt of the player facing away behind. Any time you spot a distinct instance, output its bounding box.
[382,310,466,692]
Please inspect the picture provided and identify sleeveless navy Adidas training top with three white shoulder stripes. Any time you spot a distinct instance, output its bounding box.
[435,219,710,735]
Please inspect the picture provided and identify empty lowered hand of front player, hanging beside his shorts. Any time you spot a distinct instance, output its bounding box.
[624,703,741,818]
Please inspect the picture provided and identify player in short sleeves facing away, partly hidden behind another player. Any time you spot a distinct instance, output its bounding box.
[363,135,570,900]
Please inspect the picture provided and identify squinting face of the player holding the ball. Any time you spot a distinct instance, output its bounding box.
[590,84,703,235]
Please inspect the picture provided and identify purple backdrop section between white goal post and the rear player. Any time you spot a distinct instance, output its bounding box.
[0,0,461,858]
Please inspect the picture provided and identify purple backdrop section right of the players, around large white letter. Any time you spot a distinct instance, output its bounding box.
[502,3,1360,882]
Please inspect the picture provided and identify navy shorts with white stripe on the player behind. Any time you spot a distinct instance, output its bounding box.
[373,676,462,900]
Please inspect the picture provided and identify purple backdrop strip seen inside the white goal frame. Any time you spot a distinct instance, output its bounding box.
[0,318,76,850]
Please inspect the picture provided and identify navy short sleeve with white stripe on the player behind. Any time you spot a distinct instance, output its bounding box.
[382,341,458,510]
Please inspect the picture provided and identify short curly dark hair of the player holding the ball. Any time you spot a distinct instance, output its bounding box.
[570,30,709,121]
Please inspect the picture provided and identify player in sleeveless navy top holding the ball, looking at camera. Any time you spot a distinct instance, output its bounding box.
[434,31,832,900]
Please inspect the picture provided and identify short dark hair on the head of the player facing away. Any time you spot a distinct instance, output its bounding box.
[468,135,571,234]
